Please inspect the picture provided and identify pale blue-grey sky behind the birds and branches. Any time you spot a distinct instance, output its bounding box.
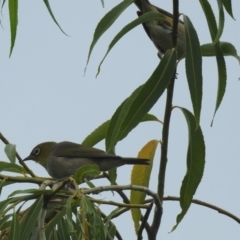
[0,0,240,240]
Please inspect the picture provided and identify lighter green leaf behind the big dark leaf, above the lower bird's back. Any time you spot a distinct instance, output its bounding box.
[82,113,162,147]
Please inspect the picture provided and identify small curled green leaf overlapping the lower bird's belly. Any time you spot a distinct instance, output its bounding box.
[74,164,100,184]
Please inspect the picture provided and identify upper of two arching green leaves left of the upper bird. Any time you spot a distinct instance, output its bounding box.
[84,0,134,72]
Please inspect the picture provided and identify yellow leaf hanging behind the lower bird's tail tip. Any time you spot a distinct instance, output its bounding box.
[130,140,159,232]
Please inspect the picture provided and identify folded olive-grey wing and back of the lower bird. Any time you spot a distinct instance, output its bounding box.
[51,142,120,158]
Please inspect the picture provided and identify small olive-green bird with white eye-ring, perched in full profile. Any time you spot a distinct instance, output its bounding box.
[24,142,149,179]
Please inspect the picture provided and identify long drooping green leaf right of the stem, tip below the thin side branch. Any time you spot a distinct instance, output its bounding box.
[172,108,205,231]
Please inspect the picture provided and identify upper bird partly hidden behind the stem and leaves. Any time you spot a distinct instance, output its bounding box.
[135,0,185,59]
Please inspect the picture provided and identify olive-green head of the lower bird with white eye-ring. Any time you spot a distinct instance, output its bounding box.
[23,142,57,167]
